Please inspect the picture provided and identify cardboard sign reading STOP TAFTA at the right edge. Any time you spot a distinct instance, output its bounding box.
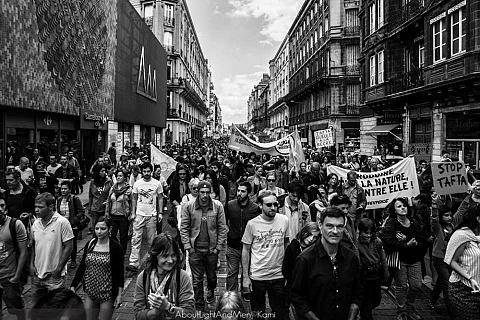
[432,161,468,195]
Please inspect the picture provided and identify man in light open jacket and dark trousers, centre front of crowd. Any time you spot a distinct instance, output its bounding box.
[180,181,228,310]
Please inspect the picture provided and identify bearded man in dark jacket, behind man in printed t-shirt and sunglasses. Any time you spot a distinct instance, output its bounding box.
[225,182,262,298]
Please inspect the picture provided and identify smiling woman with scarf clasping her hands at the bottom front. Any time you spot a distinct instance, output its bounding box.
[133,233,195,320]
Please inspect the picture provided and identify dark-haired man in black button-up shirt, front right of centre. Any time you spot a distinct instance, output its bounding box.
[292,207,363,320]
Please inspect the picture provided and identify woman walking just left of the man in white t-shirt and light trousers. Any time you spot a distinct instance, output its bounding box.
[105,169,132,253]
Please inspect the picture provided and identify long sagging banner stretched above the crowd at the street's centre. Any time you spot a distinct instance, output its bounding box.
[228,125,290,156]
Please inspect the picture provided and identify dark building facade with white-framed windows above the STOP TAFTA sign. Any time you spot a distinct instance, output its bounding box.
[360,0,480,169]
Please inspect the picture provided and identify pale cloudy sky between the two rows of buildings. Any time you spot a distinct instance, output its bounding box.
[187,0,303,123]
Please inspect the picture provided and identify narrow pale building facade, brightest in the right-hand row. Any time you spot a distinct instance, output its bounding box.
[267,37,290,139]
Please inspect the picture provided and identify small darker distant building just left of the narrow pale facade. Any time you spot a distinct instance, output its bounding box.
[247,73,270,133]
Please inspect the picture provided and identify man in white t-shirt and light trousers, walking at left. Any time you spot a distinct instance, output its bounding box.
[127,162,163,272]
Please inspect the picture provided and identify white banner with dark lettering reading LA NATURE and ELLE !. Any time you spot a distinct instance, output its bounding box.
[327,157,420,209]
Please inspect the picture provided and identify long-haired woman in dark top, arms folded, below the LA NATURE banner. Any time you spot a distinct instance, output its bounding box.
[381,198,427,319]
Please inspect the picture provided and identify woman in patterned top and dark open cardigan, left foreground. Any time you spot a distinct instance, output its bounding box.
[70,217,124,320]
